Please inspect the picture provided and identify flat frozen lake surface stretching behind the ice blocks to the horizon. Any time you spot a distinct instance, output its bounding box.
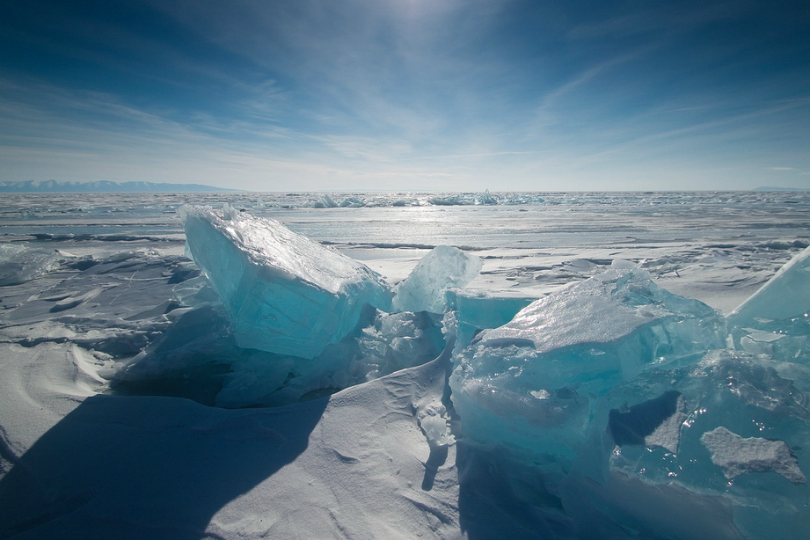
[0,192,810,311]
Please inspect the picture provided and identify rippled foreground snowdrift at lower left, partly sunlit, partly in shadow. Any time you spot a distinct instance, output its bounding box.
[0,352,458,539]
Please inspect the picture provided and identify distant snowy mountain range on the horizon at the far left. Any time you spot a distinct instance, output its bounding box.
[0,180,239,193]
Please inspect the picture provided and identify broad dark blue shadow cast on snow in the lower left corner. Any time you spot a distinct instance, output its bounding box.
[0,395,328,540]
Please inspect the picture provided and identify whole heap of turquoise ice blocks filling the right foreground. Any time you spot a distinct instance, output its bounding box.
[445,254,810,538]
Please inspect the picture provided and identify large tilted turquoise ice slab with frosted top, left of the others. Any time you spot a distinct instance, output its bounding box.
[179,206,391,358]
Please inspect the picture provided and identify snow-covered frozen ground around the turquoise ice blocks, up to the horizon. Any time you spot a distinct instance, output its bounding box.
[0,193,810,539]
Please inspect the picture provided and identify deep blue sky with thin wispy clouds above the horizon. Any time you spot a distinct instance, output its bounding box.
[0,0,810,192]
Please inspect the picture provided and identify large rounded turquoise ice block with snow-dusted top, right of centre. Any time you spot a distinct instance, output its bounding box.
[450,267,725,466]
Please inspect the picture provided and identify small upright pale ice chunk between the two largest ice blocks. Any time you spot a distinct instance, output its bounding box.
[393,246,482,313]
